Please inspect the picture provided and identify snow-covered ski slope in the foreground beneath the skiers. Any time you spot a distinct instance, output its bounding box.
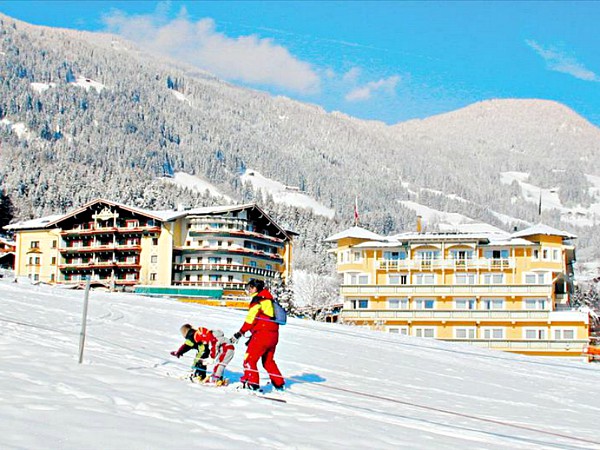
[0,280,600,450]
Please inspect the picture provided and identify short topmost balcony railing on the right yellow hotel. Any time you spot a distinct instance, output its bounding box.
[377,258,515,271]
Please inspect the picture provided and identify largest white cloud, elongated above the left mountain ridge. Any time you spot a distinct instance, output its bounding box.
[104,9,321,94]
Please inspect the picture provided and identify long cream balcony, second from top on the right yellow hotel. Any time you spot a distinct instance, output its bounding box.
[340,284,552,298]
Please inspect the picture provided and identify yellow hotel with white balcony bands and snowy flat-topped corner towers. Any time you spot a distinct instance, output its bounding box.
[326,224,590,356]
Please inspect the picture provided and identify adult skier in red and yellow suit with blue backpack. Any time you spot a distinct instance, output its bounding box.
[231,279,285,390]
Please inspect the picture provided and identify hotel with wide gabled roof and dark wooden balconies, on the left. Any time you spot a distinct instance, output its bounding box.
[5,199,293,299]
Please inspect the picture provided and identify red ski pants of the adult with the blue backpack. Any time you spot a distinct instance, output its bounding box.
[242,331,285,387]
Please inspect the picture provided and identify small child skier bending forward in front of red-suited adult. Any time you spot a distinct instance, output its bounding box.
[171,323,235,385]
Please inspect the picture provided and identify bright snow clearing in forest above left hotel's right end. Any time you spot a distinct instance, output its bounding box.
[240,169,335,219]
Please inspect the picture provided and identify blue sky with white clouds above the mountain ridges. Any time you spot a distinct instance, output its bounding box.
[0,1,600,125]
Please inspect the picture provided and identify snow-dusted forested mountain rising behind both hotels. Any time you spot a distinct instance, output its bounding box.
[0,15,600,271]
